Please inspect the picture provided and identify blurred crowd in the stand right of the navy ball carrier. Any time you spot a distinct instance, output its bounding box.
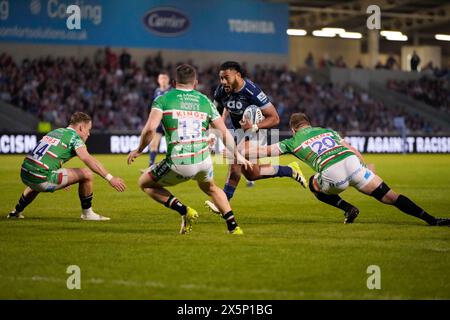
[250,66,440,133]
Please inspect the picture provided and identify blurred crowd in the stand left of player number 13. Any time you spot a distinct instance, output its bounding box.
[0,49,156,130]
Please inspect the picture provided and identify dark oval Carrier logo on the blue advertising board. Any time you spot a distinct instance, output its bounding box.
[144,7,191,36]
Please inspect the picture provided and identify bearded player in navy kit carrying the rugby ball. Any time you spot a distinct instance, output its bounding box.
[206,61,306,211]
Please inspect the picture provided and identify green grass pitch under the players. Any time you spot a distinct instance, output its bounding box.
[0,155,450,300]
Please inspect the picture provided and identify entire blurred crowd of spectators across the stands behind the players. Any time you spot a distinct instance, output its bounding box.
[0,48,442,133]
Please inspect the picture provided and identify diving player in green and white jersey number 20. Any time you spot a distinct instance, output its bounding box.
[245,113,450,226]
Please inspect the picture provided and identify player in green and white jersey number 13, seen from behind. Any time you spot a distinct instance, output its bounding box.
[128,64,252,234]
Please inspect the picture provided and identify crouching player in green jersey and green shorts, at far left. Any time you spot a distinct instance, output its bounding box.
[7,112,125,221]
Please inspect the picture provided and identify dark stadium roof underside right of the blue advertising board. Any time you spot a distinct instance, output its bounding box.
[266,0,450,46]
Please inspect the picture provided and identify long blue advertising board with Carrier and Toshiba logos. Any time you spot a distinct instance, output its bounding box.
[0,0,288,54]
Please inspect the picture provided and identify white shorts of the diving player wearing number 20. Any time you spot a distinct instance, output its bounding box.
[314,156,375,194]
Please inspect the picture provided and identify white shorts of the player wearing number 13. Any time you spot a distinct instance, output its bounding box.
[147,157,214,187]
